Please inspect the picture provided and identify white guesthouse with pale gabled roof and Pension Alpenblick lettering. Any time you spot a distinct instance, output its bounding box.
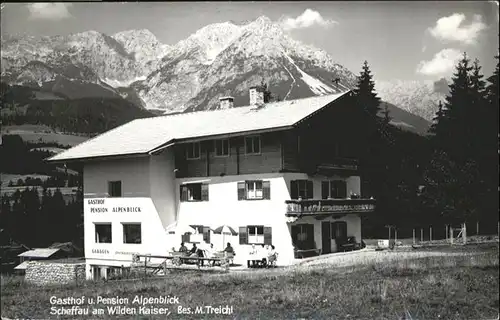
[49,87,375,278]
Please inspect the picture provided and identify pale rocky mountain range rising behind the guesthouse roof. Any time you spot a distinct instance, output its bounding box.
[1,16,436,131]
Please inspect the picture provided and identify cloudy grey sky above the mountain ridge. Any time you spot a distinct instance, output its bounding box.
[1,1,499,80]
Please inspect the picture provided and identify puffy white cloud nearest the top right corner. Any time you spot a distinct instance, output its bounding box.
[428,13,486,44]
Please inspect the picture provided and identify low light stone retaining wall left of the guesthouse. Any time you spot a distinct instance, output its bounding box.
[24,261,85,286]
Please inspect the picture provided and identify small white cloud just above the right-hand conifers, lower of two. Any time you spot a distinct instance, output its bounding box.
[416,49,462,76]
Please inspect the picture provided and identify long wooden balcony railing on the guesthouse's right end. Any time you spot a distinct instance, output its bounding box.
[285,199,376,216]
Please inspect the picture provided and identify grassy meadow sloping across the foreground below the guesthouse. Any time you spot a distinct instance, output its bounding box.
[1,243,499,320]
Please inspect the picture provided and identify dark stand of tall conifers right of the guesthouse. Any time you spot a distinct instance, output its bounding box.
[353,53,499,237]
